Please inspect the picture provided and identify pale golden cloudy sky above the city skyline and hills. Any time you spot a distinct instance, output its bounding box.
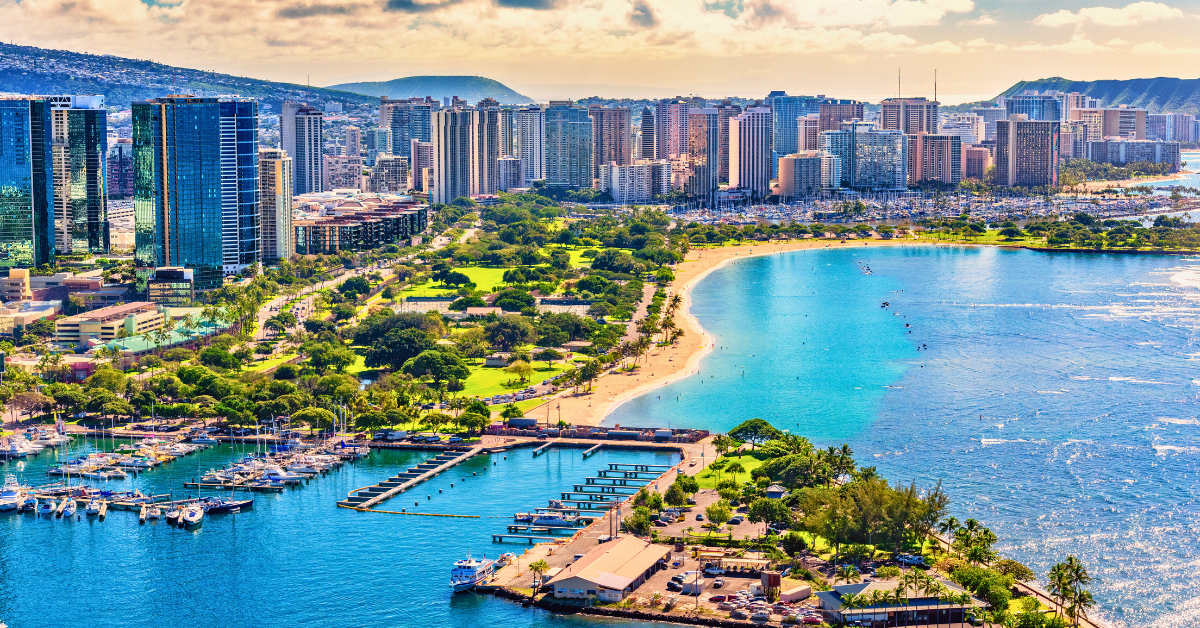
[7,0,1200,104]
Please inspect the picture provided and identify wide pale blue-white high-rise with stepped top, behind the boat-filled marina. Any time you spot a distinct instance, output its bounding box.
[821,120,908,190]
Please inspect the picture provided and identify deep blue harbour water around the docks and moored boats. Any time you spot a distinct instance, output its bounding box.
[0,445,678,628]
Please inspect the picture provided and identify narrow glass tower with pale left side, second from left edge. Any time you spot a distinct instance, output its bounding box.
[46,96,108,255]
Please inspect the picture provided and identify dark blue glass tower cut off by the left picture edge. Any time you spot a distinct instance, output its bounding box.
[0,98,54,267]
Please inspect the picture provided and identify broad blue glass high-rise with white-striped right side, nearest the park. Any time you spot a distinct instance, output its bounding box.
[133,96,260,291]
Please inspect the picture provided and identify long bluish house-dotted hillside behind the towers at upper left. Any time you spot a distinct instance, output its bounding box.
[0,43,376,113]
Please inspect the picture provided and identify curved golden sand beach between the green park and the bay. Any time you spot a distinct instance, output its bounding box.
[526,239,916,425]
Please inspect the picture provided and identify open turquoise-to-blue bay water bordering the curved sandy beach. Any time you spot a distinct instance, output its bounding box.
[610,246,1200,627]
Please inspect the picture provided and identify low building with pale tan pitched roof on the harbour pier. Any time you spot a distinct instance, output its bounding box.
[546,535,676,602]
